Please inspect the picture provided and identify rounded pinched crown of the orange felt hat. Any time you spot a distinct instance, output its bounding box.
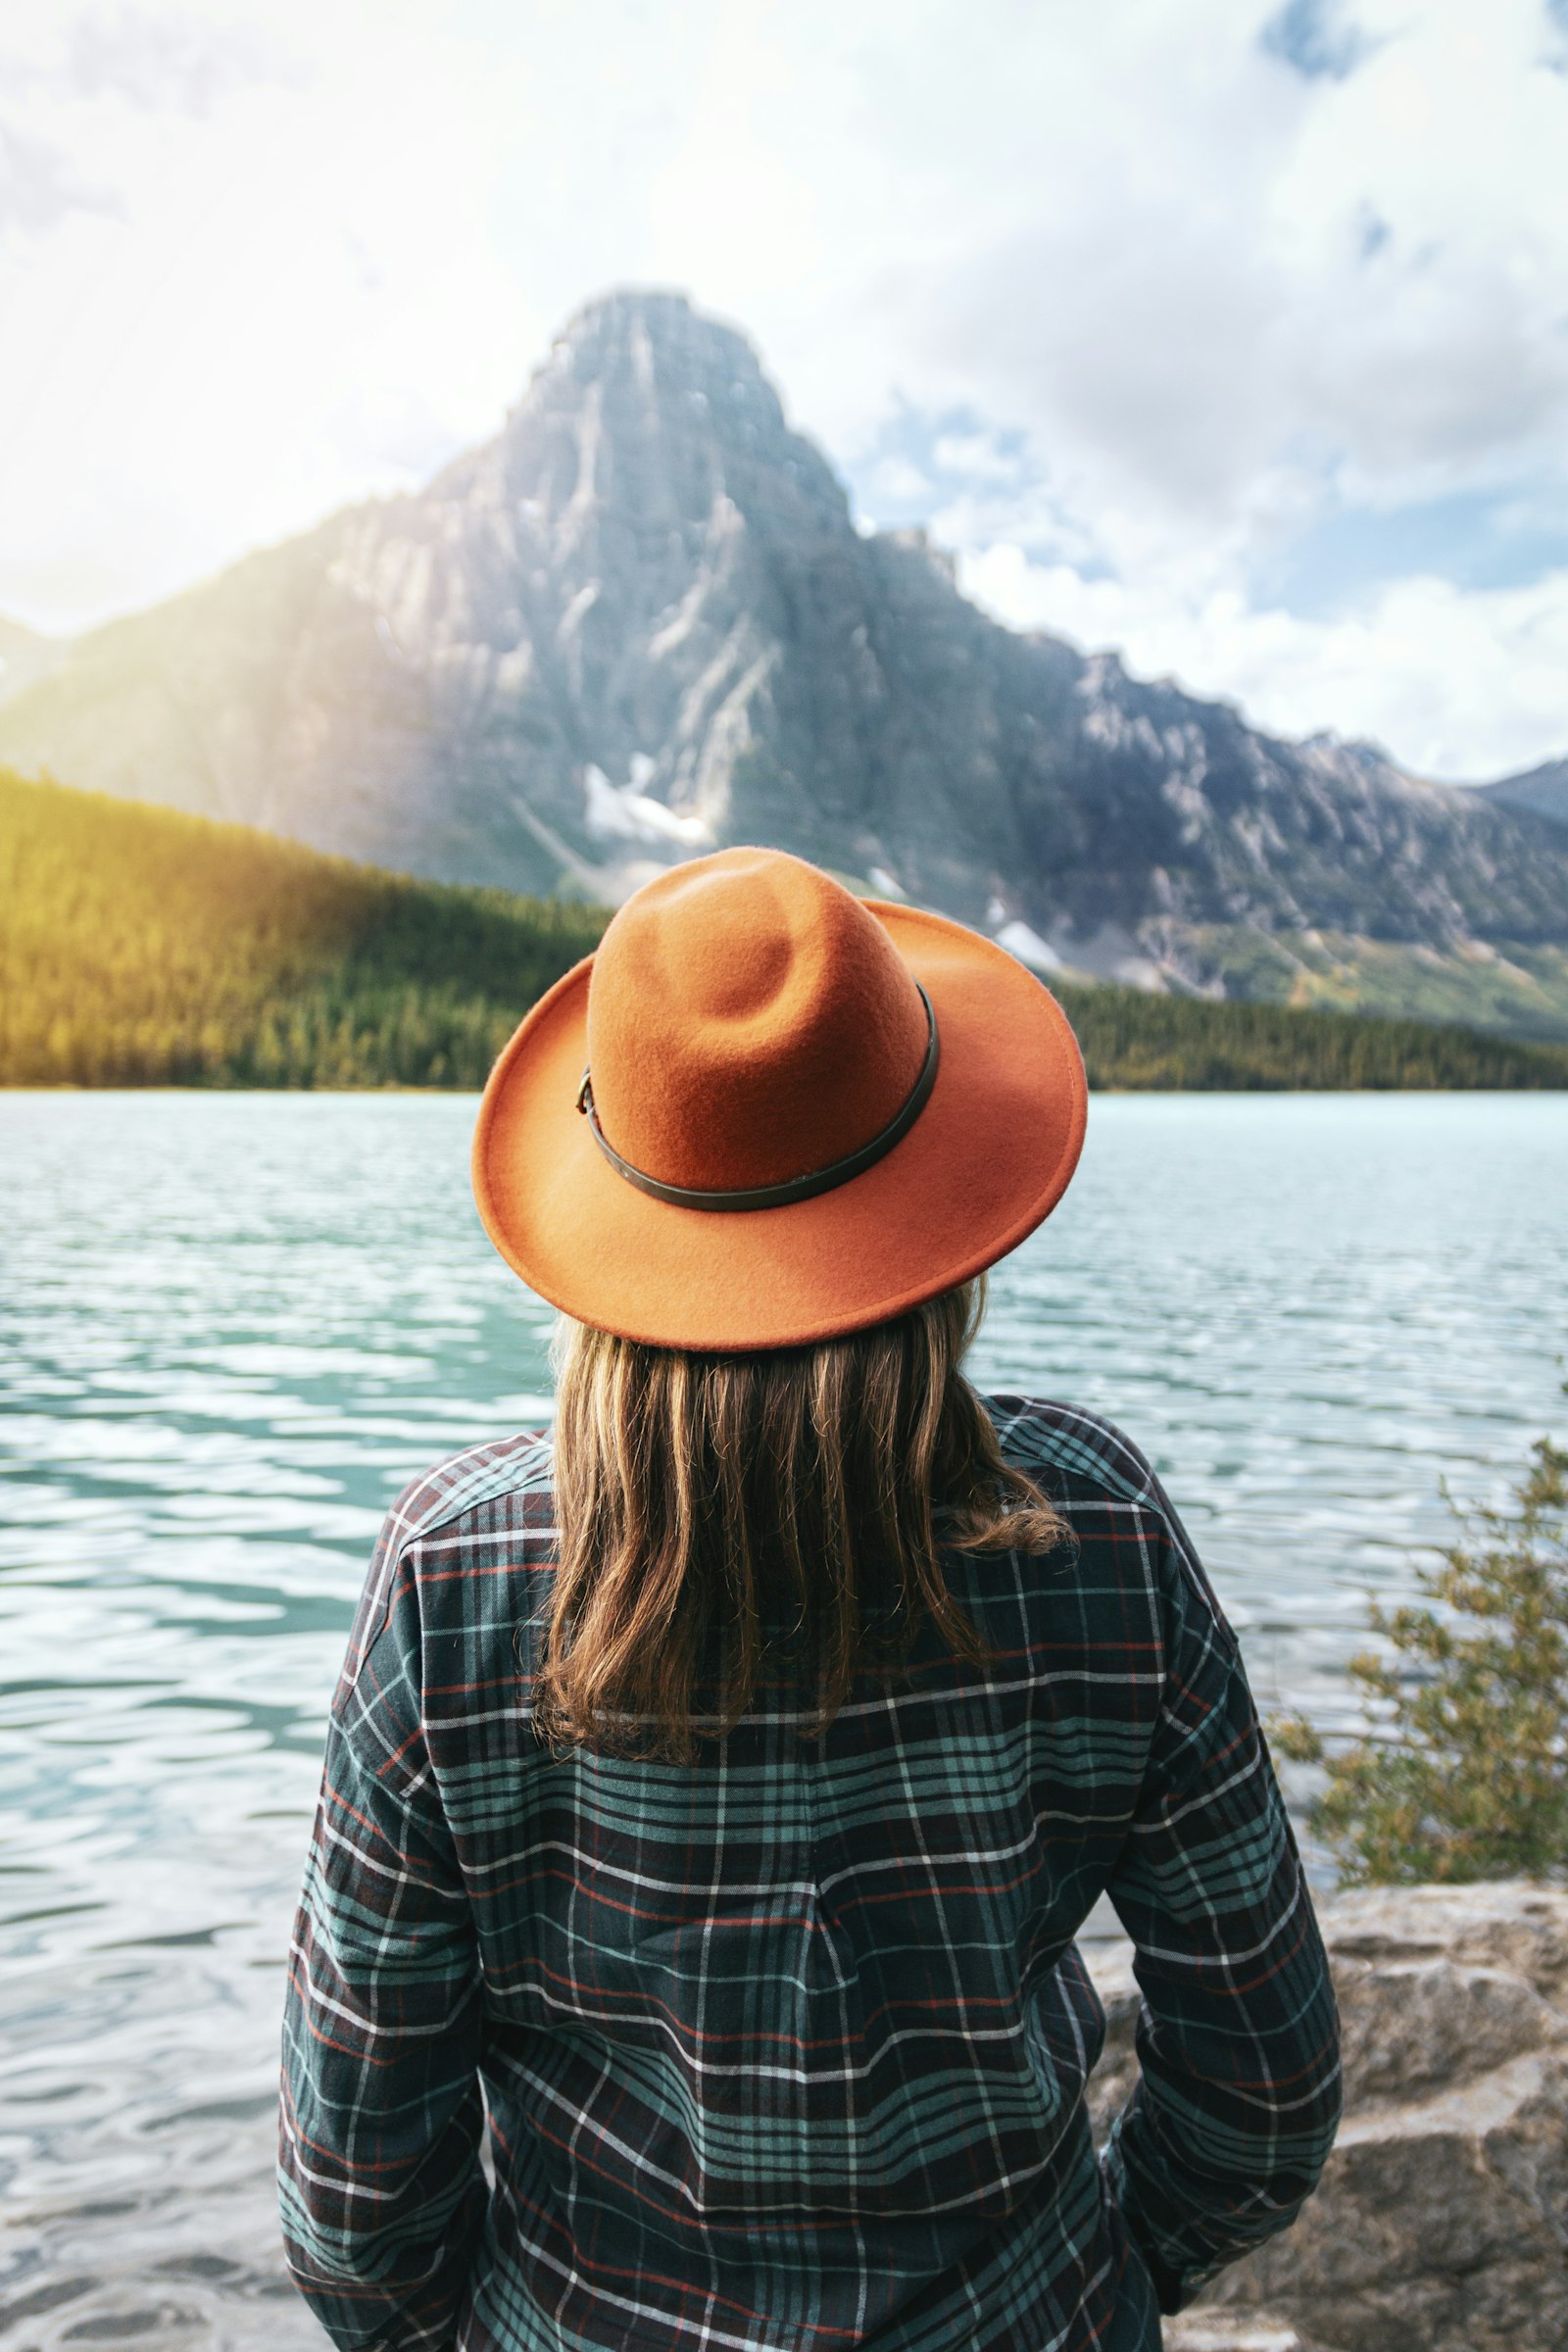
[588,849,929,1193]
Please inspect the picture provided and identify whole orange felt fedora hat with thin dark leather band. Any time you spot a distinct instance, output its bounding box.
[472,849,1086,1352]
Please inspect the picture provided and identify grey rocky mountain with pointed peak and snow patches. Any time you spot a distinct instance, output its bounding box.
[0,294,1568,978]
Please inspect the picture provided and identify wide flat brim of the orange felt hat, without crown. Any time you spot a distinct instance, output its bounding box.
[472,904,1089,1352]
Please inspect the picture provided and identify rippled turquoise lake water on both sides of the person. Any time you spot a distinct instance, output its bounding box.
[0,1094,1568,2352]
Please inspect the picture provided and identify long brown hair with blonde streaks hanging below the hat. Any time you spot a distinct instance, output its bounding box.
[536,1282,1065,1762]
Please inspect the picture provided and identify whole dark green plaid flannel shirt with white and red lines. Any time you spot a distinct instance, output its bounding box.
[279,1397,1338,2352]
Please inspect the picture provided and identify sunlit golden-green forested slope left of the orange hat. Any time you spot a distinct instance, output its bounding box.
[0,771,604,1087]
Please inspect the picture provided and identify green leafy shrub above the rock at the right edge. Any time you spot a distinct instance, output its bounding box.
[1272,1401,1568,1886]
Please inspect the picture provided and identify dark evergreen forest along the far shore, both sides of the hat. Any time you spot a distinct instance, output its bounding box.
[0,771,1568,1089]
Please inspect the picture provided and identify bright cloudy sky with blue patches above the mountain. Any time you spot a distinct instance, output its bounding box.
[0,0,1568,781]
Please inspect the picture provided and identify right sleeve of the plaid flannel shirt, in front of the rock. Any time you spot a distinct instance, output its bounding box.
[1104,1531,1340,2312]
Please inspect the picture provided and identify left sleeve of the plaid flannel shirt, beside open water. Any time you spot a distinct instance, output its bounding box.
[279,1552,489,2352]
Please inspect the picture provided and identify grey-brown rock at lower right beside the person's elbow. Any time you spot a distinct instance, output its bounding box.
[1084,1884,1568,2352]
